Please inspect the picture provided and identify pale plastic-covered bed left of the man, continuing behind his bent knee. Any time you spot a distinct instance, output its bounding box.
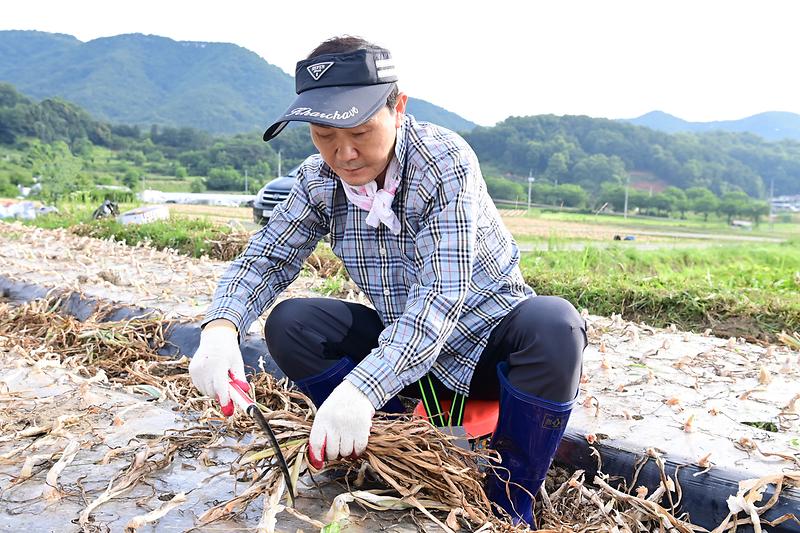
[0,218,362,331]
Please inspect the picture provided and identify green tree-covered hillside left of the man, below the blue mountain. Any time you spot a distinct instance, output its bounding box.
[0,83,286,201]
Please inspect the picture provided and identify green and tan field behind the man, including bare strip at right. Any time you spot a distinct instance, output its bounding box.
[12,200,800,339]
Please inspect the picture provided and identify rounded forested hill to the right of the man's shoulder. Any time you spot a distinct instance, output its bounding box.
[465,115,800,198]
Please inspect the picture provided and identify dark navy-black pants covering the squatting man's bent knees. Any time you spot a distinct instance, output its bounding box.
[264,296,586,402]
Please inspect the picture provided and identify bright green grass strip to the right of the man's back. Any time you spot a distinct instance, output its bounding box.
[521,242,800,339]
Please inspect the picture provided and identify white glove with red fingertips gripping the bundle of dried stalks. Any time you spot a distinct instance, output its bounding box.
[308,380,375,469]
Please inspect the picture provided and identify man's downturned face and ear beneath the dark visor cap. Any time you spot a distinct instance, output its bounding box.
[310,93,407,186]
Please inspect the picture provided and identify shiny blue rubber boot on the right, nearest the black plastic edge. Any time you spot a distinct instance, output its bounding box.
[486,363,575,526]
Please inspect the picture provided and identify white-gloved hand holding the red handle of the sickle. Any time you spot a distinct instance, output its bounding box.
[189,319,250,416]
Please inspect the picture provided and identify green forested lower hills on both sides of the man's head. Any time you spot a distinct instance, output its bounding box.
[0,83,800,204]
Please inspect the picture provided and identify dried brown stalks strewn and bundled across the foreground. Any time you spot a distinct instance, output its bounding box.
[0,296,800,533]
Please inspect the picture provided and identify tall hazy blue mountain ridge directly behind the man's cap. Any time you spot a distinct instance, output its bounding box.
[0,30,475,133]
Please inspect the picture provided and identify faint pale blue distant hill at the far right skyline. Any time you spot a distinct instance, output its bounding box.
[624,111,800,141]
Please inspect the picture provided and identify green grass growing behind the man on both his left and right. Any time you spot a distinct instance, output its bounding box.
[18,204,800,340]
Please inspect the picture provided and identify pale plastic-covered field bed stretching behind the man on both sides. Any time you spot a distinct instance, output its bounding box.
[0,219,800,528]
